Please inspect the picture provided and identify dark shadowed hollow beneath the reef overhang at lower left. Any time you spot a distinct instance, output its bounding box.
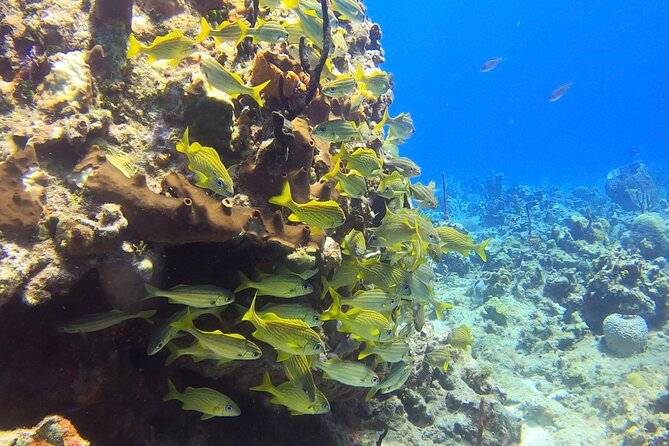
[0,246,350,445]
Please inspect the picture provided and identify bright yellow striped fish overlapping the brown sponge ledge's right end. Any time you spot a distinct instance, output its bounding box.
[269,181,346,232]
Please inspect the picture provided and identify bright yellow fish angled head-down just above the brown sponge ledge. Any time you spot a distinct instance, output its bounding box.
[176,127,234,196]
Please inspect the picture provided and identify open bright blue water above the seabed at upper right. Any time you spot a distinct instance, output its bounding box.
[365,0,669,185]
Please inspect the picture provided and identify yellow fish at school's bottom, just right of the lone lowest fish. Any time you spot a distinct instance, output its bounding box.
[249,370,330,415]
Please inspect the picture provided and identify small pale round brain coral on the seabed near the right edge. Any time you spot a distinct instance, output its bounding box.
[604,313,648,356]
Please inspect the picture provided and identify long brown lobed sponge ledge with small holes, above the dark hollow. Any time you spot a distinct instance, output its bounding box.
[74,146,324,248]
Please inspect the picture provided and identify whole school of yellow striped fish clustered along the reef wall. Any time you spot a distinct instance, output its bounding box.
[60,0,489,419]
